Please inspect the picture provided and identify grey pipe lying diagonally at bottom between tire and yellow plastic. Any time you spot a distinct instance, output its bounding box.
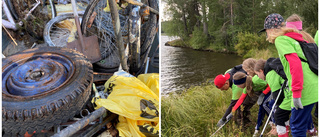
[53,107,107,137]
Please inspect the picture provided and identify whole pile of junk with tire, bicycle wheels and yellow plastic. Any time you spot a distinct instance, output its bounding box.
[2,0,159,137]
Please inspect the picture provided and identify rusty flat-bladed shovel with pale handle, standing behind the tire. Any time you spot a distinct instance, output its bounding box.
[67,0,101,63]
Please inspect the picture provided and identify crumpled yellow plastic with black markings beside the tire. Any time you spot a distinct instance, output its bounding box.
[92,74,159,137]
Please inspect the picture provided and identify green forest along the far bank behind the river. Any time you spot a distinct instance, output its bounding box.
[161,0,318,58]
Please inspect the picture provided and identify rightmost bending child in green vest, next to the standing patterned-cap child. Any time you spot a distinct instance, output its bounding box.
[254,58,292,136]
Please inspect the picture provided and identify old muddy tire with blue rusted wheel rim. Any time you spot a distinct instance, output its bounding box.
[2,47,93,136]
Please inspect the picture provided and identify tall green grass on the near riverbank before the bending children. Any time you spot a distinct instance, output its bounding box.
[161,84,258,137]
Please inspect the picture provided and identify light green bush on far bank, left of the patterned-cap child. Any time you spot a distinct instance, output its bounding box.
[235,32,273,58]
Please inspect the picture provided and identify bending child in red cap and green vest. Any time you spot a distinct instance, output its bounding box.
[214,65,246,127]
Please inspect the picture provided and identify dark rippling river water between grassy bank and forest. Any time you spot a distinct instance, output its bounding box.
[161,36,243,95]
